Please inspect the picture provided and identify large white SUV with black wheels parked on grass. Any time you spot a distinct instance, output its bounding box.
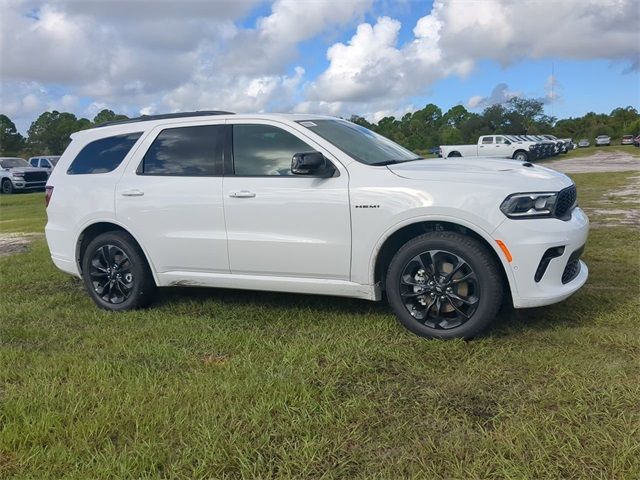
[46,112,589,338]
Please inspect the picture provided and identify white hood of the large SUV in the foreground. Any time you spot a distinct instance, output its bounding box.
[387,157,573,191]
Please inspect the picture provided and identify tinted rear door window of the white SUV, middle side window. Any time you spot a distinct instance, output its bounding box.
[138,125,225,177]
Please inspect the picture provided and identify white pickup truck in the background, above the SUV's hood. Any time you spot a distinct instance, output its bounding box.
[440,135,537,162]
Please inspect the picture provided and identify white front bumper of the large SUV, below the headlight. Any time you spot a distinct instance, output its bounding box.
[493,208,589,308]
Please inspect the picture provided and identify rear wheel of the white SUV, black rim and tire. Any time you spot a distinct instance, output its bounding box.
[81,231,156,311]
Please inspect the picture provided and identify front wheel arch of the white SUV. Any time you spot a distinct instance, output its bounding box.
[371,219,515,301]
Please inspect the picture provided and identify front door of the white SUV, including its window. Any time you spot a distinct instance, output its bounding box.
[223,121,351,280]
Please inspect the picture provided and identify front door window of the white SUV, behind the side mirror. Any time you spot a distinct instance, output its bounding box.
[233,125,314,176]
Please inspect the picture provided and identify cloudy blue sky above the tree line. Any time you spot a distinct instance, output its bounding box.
[0,0,640,132]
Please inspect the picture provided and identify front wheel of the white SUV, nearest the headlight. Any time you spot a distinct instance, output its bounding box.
[385,232,504,339]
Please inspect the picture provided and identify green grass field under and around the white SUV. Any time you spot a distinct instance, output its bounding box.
[0,172,640,479]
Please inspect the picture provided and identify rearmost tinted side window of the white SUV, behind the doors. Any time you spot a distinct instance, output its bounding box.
[67,132,142,175]
